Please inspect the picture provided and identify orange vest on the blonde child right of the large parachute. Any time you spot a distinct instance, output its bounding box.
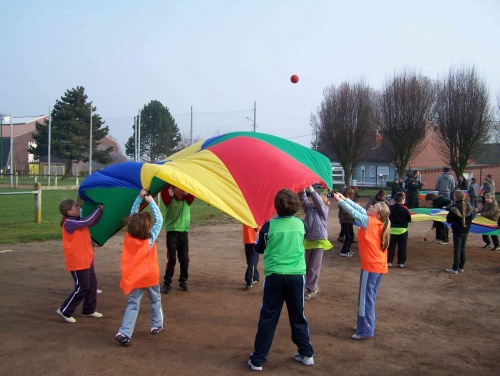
[358,217,389,274]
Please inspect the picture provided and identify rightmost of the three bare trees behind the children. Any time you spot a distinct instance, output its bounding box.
[435,67,494,177]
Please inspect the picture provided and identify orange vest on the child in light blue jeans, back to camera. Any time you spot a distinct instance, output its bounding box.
[120,233,160,295]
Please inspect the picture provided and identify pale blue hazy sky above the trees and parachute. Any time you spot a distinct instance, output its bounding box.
[0,0,500,152]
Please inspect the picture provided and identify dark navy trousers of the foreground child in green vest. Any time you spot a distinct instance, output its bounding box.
[250,274,314,366]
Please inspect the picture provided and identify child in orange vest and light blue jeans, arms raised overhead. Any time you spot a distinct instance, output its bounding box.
[115,189,164,347]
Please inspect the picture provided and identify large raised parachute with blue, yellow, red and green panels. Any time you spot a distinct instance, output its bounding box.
[79,132,332,245]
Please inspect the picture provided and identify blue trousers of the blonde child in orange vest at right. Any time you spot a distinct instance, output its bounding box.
[356,270,382,337]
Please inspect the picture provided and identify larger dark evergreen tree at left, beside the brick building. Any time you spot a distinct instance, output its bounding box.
[28,86,113,176]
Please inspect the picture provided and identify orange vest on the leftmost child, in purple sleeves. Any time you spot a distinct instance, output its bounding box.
[62,223,94,271]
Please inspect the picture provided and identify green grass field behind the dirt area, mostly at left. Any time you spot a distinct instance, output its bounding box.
[0,182,375,244]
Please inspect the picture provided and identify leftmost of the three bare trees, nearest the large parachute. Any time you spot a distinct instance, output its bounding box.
[311,80,375,185]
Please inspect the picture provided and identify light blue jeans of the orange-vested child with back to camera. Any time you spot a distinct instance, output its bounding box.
[118,284,163,338]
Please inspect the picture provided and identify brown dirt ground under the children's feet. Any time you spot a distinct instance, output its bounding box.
[0,198,500,376]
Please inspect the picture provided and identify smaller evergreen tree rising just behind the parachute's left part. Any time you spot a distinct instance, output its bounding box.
[125,100,181,162]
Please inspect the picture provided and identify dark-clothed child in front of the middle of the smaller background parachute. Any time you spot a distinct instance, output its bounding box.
[446,190,476,274]
